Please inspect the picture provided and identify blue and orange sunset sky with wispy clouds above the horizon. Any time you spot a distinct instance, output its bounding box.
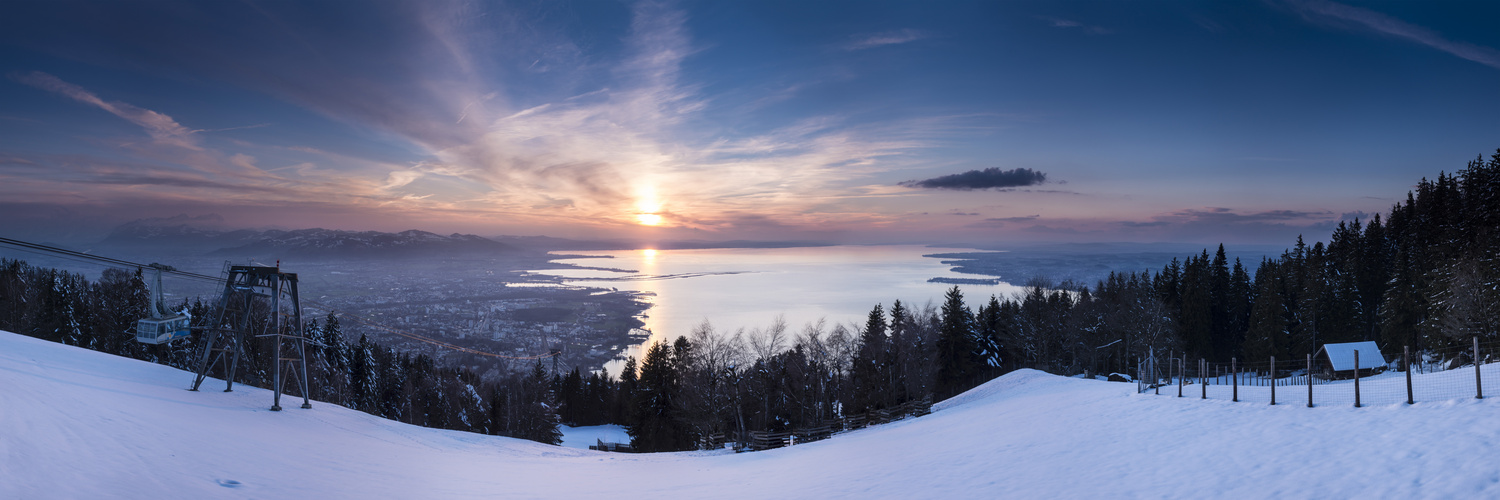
[0,0,1500,243]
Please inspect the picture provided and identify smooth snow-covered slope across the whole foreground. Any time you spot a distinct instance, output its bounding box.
[0,332,1500,498]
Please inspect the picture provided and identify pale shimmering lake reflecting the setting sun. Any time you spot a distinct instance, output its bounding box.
[522,245,1020,369]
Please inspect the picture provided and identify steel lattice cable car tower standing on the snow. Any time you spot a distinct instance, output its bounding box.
[189,266,312,411]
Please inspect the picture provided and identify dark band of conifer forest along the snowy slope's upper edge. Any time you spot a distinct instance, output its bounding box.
[0,150,1500,452]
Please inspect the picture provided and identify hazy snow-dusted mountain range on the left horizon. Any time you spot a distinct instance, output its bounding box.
[99,221,527,258]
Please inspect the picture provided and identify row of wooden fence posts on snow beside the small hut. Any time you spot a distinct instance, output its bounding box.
[1137,338,1500,407]
